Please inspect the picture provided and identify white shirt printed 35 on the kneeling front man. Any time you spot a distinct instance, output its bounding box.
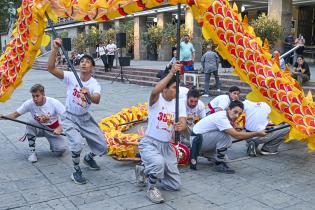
[145,94,186,142]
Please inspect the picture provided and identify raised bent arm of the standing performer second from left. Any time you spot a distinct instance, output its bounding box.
[47,38,64,79]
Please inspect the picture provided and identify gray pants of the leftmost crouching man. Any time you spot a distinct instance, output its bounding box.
[26,120,67,153]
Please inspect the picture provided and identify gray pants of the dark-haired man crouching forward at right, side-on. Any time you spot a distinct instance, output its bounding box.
[192,131,232,162]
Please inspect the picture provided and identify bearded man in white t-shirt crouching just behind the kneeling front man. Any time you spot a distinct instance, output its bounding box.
[179,89,206,146]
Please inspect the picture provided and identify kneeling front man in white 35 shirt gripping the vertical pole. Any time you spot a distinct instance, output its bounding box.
[135,64,186,203]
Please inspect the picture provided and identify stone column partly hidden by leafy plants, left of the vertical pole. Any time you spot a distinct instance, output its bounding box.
[156,12,172,61]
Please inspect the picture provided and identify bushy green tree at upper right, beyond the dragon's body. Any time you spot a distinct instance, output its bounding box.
[251,13,284,47]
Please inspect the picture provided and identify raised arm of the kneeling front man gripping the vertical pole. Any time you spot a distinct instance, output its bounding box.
[149,64,181,106]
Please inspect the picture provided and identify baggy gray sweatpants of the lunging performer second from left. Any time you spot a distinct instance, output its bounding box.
[61,112,107,155]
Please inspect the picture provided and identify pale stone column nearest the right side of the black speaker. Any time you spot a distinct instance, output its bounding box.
[134,16,147,60]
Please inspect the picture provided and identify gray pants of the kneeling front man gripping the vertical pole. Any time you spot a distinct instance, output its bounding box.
[139,136,181,190]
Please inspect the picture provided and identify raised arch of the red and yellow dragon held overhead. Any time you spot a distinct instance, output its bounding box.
[0,0,315,150]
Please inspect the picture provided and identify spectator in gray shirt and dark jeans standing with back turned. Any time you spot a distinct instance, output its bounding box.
[201,45,221,97]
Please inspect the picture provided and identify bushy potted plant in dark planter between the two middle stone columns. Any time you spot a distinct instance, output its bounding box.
[142,25,163,60]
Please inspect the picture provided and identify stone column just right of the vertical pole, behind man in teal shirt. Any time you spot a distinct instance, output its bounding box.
[185,9,203,62]
